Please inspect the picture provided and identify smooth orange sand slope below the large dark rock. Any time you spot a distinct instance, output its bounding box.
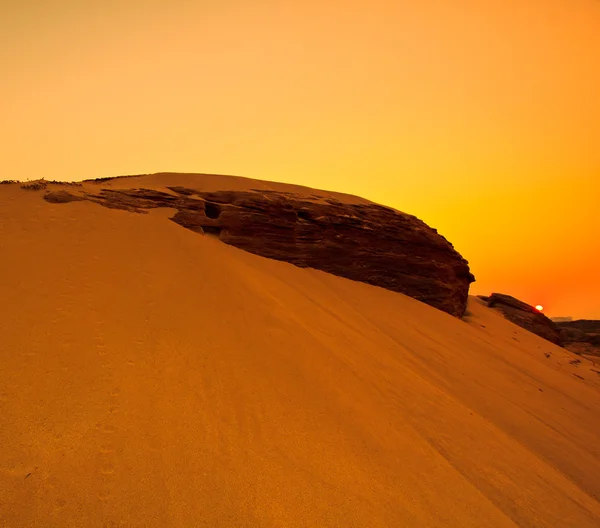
[0,181,600,528]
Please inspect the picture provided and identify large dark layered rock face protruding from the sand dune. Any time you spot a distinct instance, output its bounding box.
[42,187,474,317]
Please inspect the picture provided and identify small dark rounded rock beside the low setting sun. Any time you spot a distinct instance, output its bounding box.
[487,293,562,346]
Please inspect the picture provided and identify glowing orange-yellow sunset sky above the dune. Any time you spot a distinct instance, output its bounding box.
[0,0,600,319]
